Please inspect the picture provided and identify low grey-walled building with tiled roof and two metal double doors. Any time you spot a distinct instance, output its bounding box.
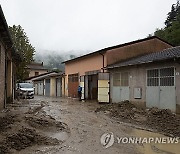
[107,46,180,113]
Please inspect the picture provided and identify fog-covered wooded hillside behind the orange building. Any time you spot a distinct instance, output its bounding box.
[34,50,91,71]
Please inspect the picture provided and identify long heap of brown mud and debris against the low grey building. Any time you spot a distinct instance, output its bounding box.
[95,101,180,137]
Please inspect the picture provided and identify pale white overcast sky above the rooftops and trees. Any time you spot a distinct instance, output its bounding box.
[0,0,176,54]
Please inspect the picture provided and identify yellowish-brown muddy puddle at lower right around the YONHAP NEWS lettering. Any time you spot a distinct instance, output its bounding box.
[131,129,180,154]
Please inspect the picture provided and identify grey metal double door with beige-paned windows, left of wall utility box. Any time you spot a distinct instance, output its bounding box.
[111,72,130,103]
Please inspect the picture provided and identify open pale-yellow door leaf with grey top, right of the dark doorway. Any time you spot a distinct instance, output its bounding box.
[98,73,109,103]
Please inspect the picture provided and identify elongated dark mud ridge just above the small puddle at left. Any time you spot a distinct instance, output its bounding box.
[25,117,68,131]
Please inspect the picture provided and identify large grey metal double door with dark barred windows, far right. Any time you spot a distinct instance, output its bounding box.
[146,67,176,111]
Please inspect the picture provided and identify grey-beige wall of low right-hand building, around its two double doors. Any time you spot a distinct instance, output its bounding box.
[109,62,180,113]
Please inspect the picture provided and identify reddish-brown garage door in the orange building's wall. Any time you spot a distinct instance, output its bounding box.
[68,74,79,98]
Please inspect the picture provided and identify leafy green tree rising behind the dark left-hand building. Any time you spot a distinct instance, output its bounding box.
[9,25,35,81]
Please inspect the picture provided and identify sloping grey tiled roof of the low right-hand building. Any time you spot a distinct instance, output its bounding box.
[107,46,180,69]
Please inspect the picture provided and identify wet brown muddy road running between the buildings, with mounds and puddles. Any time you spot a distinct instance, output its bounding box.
[0,96,180,154]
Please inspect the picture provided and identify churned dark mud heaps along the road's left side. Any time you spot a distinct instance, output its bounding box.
[0,100,69,154]
